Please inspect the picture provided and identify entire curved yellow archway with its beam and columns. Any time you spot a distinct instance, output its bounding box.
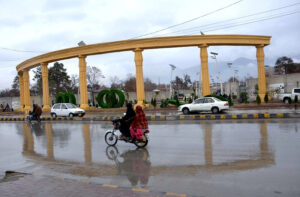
[17,35,271,111]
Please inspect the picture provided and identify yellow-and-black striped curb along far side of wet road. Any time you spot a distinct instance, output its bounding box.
[0,113,300,121]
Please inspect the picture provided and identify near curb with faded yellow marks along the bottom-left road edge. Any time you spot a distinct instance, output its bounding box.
[9,171,194,197]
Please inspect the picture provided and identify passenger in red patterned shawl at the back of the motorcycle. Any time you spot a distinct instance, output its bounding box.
[130,106,148,140]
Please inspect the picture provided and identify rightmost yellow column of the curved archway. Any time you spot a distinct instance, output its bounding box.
[256,45,267,102]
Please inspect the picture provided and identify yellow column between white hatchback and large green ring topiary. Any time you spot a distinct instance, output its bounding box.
[79,55,89,109]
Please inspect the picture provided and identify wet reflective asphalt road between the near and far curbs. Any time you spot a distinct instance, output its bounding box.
[0,119,300,196]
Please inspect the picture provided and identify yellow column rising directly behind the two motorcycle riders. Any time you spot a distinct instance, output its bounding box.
[134,48,145,105]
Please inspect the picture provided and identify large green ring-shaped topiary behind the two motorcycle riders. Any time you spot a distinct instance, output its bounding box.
[96,89,125,108]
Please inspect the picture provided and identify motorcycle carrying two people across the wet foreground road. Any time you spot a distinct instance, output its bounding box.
[105,119,149,148]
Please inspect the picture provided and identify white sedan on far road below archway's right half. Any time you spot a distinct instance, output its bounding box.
[178,97,229,114]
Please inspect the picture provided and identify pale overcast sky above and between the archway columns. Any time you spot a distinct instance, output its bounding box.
[0,0,300,89]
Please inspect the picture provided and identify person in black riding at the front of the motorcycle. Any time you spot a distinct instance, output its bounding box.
[120,103,135,139]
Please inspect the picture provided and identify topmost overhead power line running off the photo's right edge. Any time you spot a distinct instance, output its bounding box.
[157,3,300,35]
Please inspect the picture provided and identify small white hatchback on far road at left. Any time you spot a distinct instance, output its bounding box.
[51,103,85,118]
